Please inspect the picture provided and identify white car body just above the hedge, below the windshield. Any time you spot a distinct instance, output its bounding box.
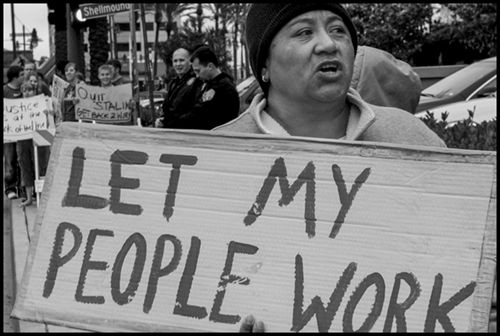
[415,94,497,126]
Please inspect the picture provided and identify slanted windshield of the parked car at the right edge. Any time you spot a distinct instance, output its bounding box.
[422,62,496,98]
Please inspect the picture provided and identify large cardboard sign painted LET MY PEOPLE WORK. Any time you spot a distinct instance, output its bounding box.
[13,123,496,332]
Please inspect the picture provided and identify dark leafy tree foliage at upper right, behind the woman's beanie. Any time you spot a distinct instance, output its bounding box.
[346,3,497,66]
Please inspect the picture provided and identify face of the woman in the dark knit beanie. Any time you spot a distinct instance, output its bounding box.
[266,10,355,103]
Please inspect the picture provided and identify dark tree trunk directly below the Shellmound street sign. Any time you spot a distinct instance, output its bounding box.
[89,17,110,85]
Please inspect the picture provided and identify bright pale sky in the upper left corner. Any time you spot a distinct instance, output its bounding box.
[3,3,50,60]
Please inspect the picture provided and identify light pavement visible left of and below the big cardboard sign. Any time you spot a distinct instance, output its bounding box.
[8,196,86,333]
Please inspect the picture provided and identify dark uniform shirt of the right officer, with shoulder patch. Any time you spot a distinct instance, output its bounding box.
[171,73,240,130]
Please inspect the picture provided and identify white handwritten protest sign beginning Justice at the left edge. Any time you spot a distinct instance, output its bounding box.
[3,95,48,143]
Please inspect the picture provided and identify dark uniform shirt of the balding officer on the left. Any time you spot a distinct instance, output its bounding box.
[162,69,203,128]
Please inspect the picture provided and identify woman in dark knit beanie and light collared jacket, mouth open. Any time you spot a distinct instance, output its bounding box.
[216,3,445,147]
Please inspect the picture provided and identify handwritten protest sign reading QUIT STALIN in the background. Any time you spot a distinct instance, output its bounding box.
[75,84,132,123]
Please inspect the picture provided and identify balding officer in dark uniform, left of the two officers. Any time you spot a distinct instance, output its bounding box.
[156,48,203,128]
